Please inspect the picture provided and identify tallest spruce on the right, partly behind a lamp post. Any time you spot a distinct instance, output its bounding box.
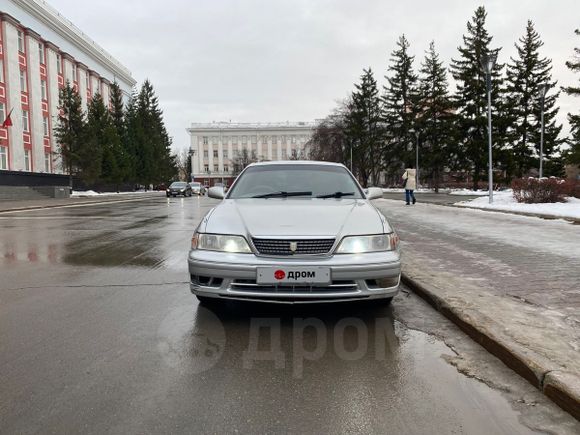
[450,6,507,189]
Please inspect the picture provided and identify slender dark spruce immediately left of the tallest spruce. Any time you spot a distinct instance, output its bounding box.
[416,42,456,191]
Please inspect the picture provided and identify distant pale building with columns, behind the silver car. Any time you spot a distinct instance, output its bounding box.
[187,122,315,186]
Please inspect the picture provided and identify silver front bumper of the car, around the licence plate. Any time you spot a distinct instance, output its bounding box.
[188,250,401,303]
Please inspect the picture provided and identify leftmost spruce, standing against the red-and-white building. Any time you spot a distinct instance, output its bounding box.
[55,81,86,189]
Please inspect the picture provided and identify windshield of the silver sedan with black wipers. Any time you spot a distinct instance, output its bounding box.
[228,164,363,199]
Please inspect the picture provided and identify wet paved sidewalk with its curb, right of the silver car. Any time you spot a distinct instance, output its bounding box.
[376,199,580,419]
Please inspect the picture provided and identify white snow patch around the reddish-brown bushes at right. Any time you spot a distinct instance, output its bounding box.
[455,190,580,219]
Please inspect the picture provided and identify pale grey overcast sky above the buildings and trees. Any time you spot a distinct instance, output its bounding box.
[49,0,580,148]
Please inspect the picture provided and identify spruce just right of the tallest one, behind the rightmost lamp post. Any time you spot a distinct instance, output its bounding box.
[506,20,562,177]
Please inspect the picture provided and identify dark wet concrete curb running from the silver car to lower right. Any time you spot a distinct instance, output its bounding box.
[401,273,580,421]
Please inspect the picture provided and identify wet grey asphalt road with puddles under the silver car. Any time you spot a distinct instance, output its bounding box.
[0,197,577,434]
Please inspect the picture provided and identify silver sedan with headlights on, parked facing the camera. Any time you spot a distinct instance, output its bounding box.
[188,162,401,303]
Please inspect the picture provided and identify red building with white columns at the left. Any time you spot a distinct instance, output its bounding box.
[0,0,135,173]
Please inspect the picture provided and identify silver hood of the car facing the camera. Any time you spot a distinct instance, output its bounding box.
[200,198,392,238]
